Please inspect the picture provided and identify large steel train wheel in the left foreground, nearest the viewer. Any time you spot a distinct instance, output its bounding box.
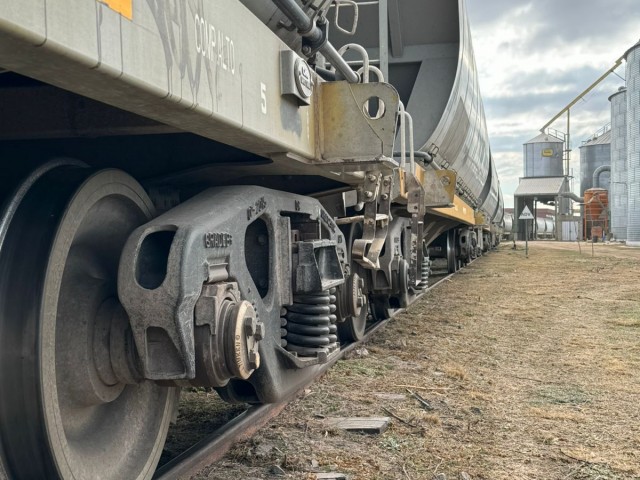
[0,163,178,479]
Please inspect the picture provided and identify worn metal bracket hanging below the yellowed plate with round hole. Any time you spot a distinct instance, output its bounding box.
[352,175,393,269]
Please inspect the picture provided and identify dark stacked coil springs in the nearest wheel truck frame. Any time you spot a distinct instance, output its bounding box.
[281,289,338,357]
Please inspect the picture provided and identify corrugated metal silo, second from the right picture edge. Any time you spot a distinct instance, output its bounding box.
[609,87,629,240]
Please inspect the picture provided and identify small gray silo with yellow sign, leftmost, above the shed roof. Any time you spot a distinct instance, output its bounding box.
[524,133,564,177]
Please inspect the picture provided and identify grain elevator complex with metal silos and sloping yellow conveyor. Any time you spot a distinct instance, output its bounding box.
[504,41,640,247]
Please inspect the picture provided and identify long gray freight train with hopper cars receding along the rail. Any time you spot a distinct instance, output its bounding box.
[0,0,503,479]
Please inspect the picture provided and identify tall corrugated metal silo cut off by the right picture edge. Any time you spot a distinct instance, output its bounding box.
[625,42,640,247]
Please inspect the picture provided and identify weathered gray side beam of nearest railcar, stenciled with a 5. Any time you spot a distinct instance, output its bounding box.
[0,0,317,159]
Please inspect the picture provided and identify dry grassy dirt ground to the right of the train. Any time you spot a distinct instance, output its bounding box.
[169,242,640,480]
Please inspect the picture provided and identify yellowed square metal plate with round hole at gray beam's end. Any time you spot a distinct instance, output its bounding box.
[319,82,400,170]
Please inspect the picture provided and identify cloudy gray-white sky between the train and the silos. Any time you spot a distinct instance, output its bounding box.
[466,0,640,207]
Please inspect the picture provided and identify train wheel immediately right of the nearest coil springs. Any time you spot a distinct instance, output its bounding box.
[338,223,369,342]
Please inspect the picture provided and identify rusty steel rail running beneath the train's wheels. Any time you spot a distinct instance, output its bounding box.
[154,273,454,480]
